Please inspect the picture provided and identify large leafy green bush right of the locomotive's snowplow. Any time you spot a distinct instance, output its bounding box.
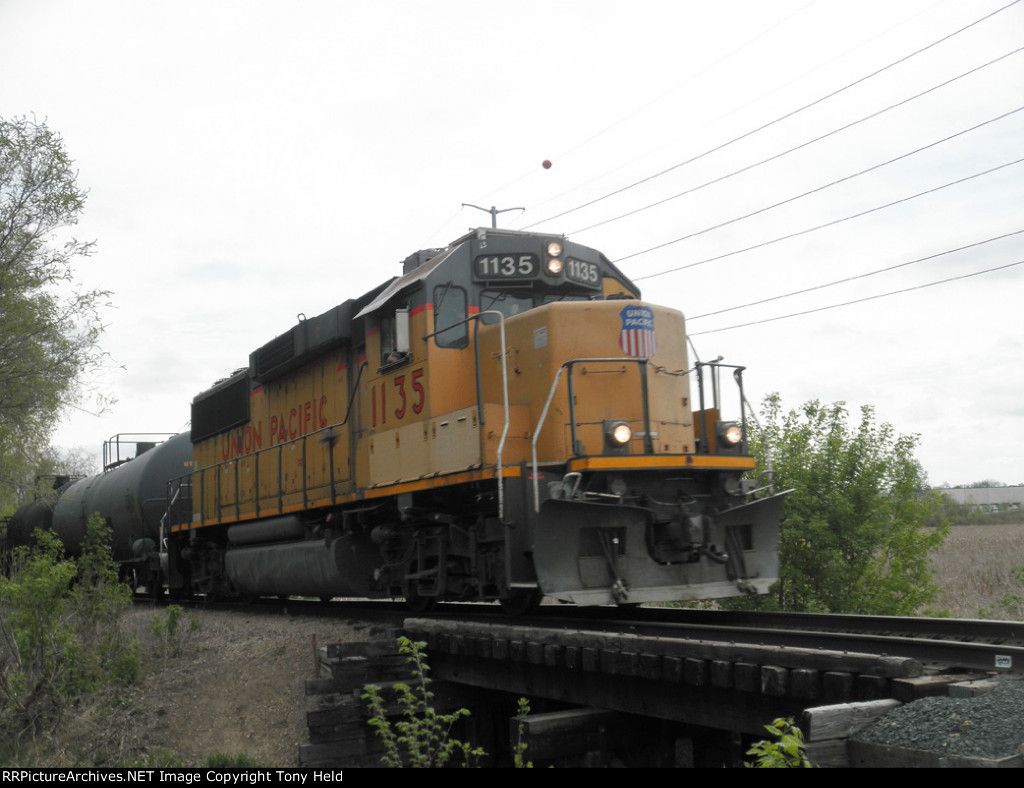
[753,395,948,615]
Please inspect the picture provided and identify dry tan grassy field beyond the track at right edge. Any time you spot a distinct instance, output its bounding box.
[922,521,1024,619]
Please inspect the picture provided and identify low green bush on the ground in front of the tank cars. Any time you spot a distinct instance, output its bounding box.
[0,516,141,749]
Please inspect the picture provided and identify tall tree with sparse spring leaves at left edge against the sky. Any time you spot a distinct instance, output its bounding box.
[0,112,109,515]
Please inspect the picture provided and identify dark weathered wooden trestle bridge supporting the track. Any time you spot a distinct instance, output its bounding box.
[301,605,1020,767]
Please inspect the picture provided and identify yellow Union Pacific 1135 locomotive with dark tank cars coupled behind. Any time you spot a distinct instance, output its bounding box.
[11,228,781,612]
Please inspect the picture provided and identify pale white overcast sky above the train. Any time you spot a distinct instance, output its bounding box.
[0,0,1024,485]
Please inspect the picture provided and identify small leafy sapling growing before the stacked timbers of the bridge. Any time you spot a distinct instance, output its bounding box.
[362,638,486,769]
